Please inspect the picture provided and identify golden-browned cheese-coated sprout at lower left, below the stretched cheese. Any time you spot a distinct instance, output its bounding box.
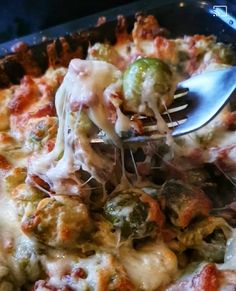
[21,195,91,248]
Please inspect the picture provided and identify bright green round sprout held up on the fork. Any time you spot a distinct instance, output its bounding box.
[123,57,173,112]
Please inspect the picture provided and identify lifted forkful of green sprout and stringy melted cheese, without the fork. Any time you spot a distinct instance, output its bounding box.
[26,58,175,194]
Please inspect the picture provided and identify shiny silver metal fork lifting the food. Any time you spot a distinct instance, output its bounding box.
[92,67,236,143]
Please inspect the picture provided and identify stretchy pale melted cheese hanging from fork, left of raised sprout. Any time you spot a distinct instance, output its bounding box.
[29,59,130,194]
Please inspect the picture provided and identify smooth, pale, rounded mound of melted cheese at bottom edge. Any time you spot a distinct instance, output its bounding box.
[120,242,177,291]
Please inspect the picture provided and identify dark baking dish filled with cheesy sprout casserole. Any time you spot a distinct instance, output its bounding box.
[0,0,236,291]
